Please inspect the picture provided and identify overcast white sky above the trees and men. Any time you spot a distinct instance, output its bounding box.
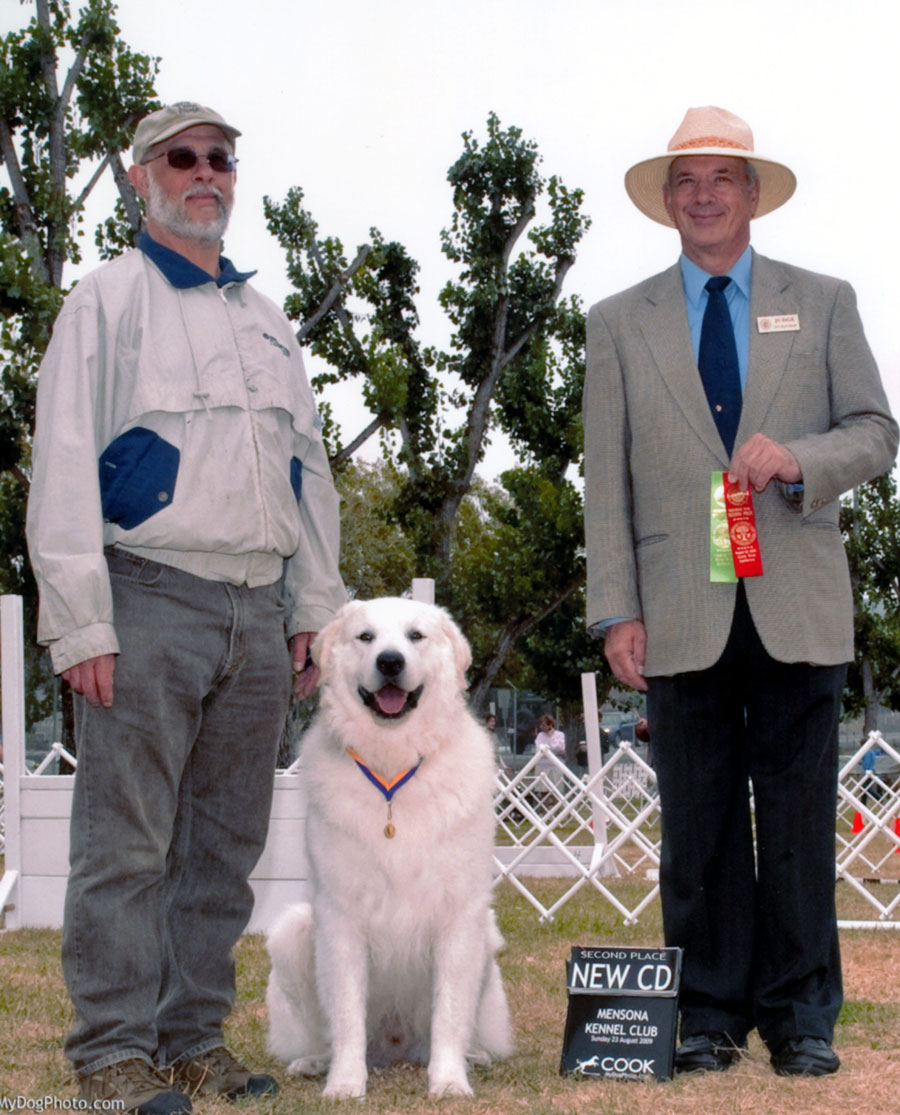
[7,0,900,474]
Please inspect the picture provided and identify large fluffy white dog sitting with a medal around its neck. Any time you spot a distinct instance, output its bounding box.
[267,599,512,1098]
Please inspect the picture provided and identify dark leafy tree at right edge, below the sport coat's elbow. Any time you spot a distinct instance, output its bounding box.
[841,473,900,735]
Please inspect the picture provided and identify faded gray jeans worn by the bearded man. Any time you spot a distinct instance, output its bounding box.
[62,551,291,1075]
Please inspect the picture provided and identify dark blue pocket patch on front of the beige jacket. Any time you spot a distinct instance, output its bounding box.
[99,426,181,531]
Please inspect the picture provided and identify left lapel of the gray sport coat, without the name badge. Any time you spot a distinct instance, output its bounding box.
[638,263,728,467]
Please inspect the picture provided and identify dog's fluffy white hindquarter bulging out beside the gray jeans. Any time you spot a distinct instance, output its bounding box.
[265,903,330,1076]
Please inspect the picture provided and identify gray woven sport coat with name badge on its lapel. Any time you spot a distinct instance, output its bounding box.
[583,252,898,677]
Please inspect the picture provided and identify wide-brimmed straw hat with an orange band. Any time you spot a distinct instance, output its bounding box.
[625,105,797,229]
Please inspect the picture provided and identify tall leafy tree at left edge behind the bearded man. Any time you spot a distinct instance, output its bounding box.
[0,0,158,717]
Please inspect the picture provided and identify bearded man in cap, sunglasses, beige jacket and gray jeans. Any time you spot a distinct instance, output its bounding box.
[28,101,345,1115]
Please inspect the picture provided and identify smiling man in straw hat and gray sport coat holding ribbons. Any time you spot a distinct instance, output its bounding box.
[584,107,898,1076]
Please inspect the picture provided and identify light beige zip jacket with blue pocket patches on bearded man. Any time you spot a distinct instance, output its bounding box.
[27,243,346,672]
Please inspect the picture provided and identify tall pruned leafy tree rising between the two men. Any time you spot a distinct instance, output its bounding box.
[264,114,604,707]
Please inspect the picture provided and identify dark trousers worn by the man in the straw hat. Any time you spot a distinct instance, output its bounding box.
[648,584,846,1048]
